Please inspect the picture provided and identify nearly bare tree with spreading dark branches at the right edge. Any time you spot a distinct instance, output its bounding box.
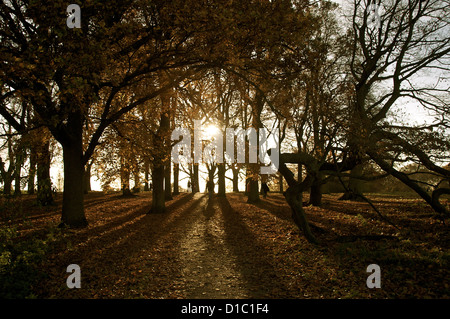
[349,0,450,216]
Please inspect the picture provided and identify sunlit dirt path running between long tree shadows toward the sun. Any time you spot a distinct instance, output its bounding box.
[179,194,248,299]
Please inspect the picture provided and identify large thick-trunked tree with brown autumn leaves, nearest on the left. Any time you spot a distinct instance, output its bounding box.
[0,0,229,227]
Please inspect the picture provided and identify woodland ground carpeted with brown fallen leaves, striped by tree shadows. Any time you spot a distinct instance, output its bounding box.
[2,192,450,298]
